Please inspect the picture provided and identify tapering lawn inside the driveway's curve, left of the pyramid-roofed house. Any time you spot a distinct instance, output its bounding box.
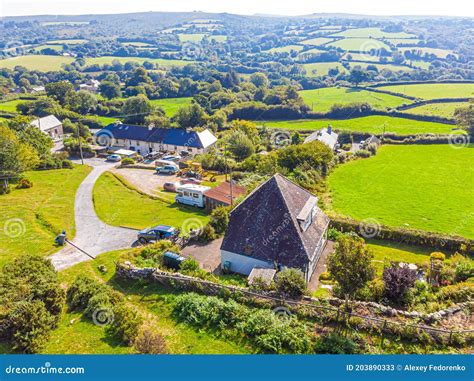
[94,172,209,233]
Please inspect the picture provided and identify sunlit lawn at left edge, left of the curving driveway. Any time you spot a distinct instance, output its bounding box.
[0,166,91,265]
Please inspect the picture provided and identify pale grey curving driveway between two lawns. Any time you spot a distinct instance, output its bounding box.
[50,159,137,271]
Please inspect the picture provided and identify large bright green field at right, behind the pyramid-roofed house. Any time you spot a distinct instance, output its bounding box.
[328,144,474,238]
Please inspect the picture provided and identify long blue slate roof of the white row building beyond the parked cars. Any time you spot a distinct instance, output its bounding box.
[96,123,217,148]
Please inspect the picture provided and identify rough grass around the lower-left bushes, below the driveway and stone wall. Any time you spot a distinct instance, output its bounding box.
[42,250,250,354]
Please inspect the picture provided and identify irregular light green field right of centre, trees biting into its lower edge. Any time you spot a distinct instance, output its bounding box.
[299,87,410,112]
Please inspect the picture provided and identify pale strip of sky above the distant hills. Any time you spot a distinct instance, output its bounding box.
[0,0,474,17]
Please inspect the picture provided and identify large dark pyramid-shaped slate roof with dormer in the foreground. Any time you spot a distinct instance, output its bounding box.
[221,174,329,269]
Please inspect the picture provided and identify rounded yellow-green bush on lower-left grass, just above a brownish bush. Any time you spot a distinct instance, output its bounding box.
[107,303,142,345]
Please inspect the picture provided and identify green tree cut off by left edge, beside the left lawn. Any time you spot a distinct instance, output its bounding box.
[0,125,40,189]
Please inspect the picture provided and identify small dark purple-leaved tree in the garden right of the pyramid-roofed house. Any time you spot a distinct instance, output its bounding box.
[382,263,416,304]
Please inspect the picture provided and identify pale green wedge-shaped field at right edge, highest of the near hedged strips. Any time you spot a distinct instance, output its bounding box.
[378,83,474,99]
